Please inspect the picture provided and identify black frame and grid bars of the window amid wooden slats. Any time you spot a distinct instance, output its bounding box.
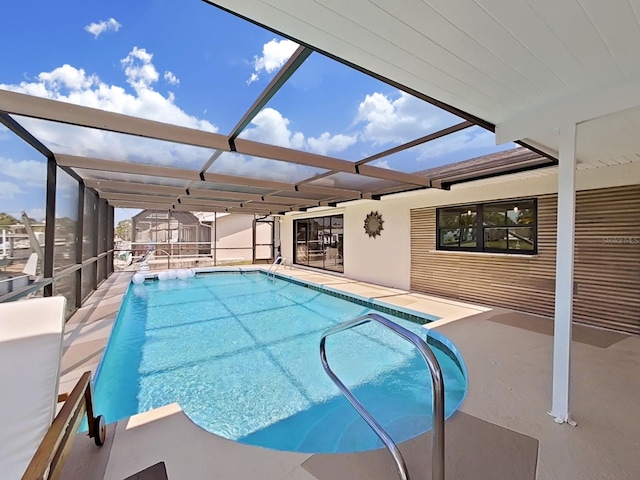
[436,198,538,256]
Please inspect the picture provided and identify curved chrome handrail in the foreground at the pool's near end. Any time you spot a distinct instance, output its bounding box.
[320,313,444,480]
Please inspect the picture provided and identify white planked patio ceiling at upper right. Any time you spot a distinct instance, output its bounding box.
[207,0,640,172]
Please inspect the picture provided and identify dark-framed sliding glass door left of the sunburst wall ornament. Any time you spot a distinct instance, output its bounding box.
[293,215,344,272]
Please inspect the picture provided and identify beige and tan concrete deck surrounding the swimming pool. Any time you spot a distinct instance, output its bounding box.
[60,268,640,480]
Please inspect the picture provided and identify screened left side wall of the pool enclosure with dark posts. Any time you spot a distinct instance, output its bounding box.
[0,126,113,317]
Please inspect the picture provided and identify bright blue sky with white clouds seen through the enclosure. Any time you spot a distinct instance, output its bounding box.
[0,0,512,225]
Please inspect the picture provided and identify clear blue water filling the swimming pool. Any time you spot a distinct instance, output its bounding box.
[95,273,466,453]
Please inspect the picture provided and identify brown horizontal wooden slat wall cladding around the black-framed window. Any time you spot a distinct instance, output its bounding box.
[411,185,640,334]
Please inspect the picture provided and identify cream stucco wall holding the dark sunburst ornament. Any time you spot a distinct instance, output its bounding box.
[281,162,640,290]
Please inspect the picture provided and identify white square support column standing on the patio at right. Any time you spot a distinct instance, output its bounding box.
[549,124,576,425]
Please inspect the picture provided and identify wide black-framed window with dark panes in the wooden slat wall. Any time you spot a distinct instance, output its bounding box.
[437,199,537,254]
